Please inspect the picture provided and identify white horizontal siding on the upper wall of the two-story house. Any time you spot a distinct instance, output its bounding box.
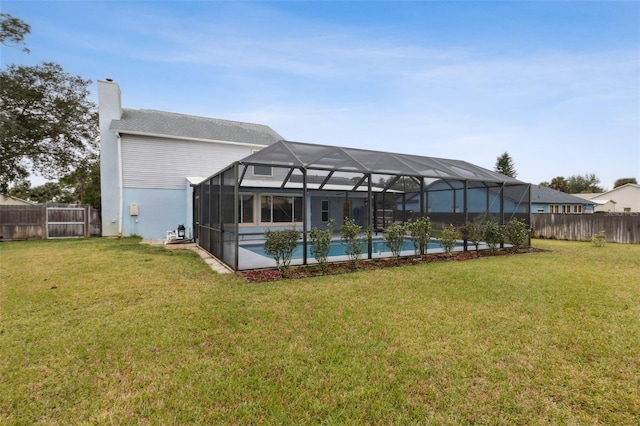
[122,135,259,190]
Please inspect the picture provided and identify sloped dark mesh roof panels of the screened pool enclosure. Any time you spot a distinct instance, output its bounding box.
[239,140,524,184]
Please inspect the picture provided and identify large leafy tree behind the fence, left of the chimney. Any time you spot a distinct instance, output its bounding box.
[0,62,98,193]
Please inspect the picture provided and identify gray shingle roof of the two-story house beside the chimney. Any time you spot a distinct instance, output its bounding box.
[110,109,284,145]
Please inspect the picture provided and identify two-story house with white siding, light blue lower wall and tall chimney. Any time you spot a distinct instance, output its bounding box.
[98,80,283,240]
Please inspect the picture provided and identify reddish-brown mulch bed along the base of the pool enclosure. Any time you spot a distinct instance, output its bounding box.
[237,248,545,283]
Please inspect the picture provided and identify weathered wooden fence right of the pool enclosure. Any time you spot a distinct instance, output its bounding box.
[531,213,640,244]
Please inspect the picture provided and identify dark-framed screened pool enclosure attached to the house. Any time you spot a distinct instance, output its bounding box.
[193,141,531,270]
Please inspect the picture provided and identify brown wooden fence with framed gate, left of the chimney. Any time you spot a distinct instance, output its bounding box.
[0,205,102,241]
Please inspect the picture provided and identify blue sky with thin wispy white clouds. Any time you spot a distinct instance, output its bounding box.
[0,0,640,189]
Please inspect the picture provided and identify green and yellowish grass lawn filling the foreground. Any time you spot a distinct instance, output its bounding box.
[0,239,640,425]
